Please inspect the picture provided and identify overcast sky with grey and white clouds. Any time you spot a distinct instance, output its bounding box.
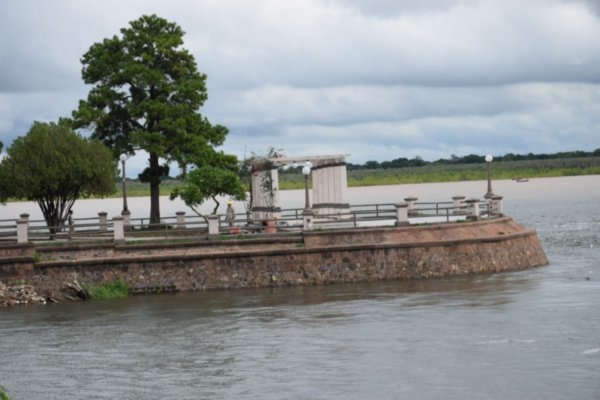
[0,0,600,173]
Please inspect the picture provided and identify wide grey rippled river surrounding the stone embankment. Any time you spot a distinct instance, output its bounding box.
[0,176,600,400]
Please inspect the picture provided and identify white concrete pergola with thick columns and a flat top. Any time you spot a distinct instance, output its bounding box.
[252,154,350,220]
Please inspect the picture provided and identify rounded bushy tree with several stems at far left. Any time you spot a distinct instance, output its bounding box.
[0,122,117,233]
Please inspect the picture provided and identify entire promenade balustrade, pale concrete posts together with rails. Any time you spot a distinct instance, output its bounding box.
[0,195,504,243]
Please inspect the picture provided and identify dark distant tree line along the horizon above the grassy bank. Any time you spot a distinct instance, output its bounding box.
[347,148,600,170]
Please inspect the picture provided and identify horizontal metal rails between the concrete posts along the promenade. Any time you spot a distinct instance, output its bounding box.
[0,201,494,242]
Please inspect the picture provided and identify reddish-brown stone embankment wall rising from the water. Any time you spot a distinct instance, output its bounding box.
[0,217,548,306]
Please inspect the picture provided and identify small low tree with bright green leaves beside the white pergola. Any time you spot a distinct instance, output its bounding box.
[171,165,246,216]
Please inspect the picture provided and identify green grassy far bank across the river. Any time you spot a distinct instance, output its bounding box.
[113,157,600,197]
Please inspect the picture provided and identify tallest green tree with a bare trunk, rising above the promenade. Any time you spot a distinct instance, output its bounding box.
[73,15,227,223]
